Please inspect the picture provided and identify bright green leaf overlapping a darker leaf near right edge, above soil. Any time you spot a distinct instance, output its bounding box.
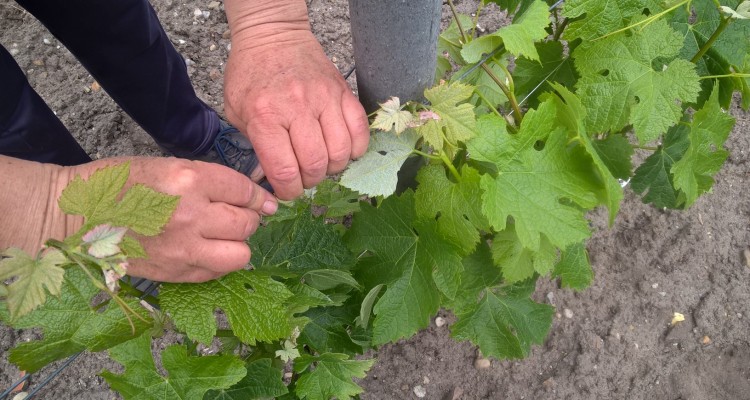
[671,86,734,207]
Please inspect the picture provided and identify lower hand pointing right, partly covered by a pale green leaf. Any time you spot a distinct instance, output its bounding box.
[72,157,277,282]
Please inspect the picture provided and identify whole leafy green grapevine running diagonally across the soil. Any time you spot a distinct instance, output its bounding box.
[0,0,750,400]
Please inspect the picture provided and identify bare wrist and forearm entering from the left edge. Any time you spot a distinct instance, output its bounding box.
[0,156,83,254]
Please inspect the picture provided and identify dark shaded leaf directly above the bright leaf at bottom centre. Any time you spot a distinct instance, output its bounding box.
[297,307,362,354]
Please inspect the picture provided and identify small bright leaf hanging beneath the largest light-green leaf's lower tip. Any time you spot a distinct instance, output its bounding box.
[492,225,557,283]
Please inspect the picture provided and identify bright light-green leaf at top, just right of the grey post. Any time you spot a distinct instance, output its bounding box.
[461,0,550,63]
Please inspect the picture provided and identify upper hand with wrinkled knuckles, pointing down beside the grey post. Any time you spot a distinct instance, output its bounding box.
[224,29,369,200]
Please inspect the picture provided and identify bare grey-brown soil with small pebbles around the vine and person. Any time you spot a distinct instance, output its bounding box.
[0,0,750,400]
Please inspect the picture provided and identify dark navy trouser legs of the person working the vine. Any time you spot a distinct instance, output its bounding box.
[0,0,219,165]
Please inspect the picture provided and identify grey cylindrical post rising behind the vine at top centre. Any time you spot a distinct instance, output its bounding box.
[349,0,442,113]
